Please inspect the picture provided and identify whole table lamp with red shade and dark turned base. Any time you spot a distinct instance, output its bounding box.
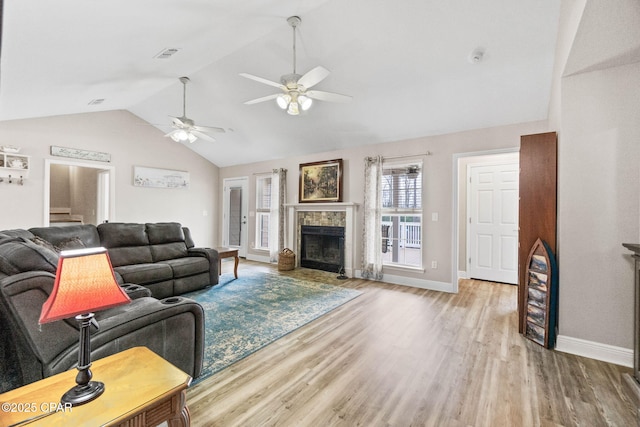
[39,248,131,406]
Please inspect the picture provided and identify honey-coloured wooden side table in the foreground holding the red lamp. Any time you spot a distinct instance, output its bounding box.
[0,347,191,427]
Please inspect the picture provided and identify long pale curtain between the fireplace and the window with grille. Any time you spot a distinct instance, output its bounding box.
[362,156,382,280]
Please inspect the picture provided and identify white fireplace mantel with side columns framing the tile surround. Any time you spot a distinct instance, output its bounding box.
[284,202,358,277]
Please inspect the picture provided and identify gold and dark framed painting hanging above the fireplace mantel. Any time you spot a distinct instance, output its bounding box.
[300,159,342,203]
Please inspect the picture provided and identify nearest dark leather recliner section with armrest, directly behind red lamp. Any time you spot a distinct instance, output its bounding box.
[0,271,204,384]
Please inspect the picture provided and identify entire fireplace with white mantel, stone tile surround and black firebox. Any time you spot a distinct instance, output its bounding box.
[286,202,358,277]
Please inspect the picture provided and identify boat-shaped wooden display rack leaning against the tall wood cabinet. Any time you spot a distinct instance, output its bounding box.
[523,239,558,348]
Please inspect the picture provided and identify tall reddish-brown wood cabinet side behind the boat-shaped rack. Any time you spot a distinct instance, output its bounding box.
[518,132,558,334]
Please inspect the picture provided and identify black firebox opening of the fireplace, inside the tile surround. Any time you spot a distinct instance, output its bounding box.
[300,225,344,273]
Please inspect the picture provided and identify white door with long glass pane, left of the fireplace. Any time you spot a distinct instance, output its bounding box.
[222,177,249,257]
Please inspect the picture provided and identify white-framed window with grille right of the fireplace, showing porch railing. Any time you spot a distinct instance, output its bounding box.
[380,161,422,268]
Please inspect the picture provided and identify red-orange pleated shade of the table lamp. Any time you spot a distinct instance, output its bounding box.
[39,248,131,324]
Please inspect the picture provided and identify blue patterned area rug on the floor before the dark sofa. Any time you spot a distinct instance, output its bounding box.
[183,272,362,384]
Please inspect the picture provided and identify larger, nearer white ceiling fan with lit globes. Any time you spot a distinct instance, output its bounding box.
[240,16,352,116]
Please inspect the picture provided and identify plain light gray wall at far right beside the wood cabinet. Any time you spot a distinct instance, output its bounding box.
[549,0,640,359]
